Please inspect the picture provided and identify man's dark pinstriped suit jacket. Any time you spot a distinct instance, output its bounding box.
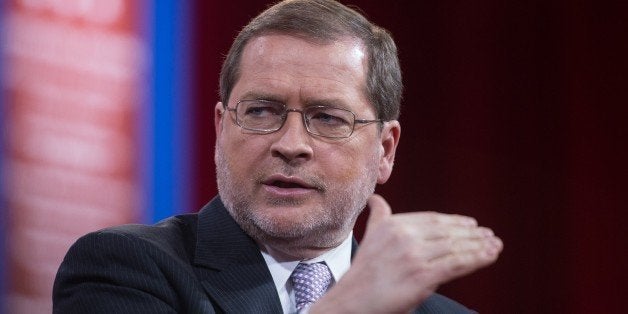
[53,197,476,313]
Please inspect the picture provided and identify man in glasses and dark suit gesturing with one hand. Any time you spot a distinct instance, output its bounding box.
[54,0,502,313]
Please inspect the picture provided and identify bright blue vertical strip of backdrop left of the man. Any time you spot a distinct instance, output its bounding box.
[144,0,193,222]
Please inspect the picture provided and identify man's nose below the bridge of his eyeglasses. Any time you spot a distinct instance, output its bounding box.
[270,111,313,163]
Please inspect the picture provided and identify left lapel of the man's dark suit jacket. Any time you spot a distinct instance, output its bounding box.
[194,197,282,313]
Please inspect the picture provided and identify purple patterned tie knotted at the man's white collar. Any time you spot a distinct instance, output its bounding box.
[290,263,331,311]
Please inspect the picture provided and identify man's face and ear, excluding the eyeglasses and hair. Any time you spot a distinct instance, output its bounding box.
[215,35,399,258]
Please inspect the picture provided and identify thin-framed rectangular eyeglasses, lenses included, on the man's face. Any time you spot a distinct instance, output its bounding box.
[226,99,382,138]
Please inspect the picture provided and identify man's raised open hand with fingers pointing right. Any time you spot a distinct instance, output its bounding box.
[310,195,502,313]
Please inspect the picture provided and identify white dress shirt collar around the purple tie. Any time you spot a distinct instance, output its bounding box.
[262,233,353,314]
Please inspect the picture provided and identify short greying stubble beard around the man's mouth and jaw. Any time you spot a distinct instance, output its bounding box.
[215,145,378,256]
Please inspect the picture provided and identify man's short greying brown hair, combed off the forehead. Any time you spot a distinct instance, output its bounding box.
[220,0,403,121]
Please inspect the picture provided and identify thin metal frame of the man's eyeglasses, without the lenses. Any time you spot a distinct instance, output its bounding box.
[224,99,384,139]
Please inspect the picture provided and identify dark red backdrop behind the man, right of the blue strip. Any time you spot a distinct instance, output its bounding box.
[194,0,628,313]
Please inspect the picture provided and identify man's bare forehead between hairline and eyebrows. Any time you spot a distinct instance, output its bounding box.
[233,34,367,110]
